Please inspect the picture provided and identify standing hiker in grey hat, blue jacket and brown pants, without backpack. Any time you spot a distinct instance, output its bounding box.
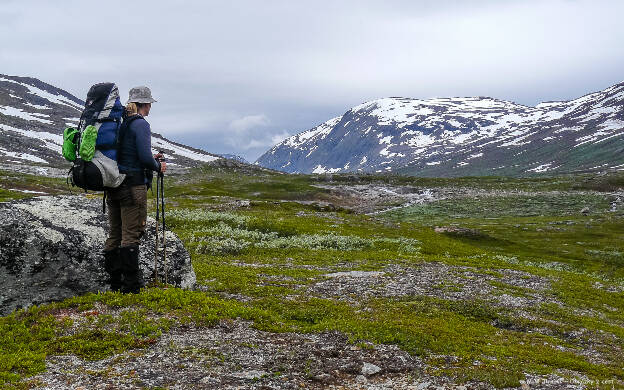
[104,87,167,293]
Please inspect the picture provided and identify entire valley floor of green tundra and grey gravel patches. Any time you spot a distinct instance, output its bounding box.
[0,165,624,390]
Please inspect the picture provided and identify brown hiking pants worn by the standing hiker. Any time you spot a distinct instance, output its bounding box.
[104,184,147,251]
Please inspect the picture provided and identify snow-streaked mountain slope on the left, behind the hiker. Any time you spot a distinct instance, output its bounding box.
[0,74,220,167]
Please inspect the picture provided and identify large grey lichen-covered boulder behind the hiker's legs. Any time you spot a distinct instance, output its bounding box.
[0,195,195,315]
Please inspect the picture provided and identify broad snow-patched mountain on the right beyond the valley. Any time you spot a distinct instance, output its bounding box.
[256,83,624,176]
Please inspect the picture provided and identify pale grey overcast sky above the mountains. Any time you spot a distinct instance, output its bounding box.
[0,0,624,161]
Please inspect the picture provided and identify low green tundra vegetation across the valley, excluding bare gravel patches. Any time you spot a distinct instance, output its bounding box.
[0,165,624,389]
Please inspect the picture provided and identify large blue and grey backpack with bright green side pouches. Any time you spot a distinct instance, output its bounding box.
[63,83,125,191]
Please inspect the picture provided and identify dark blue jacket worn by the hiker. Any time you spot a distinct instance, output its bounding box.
[117,115,160,184]
